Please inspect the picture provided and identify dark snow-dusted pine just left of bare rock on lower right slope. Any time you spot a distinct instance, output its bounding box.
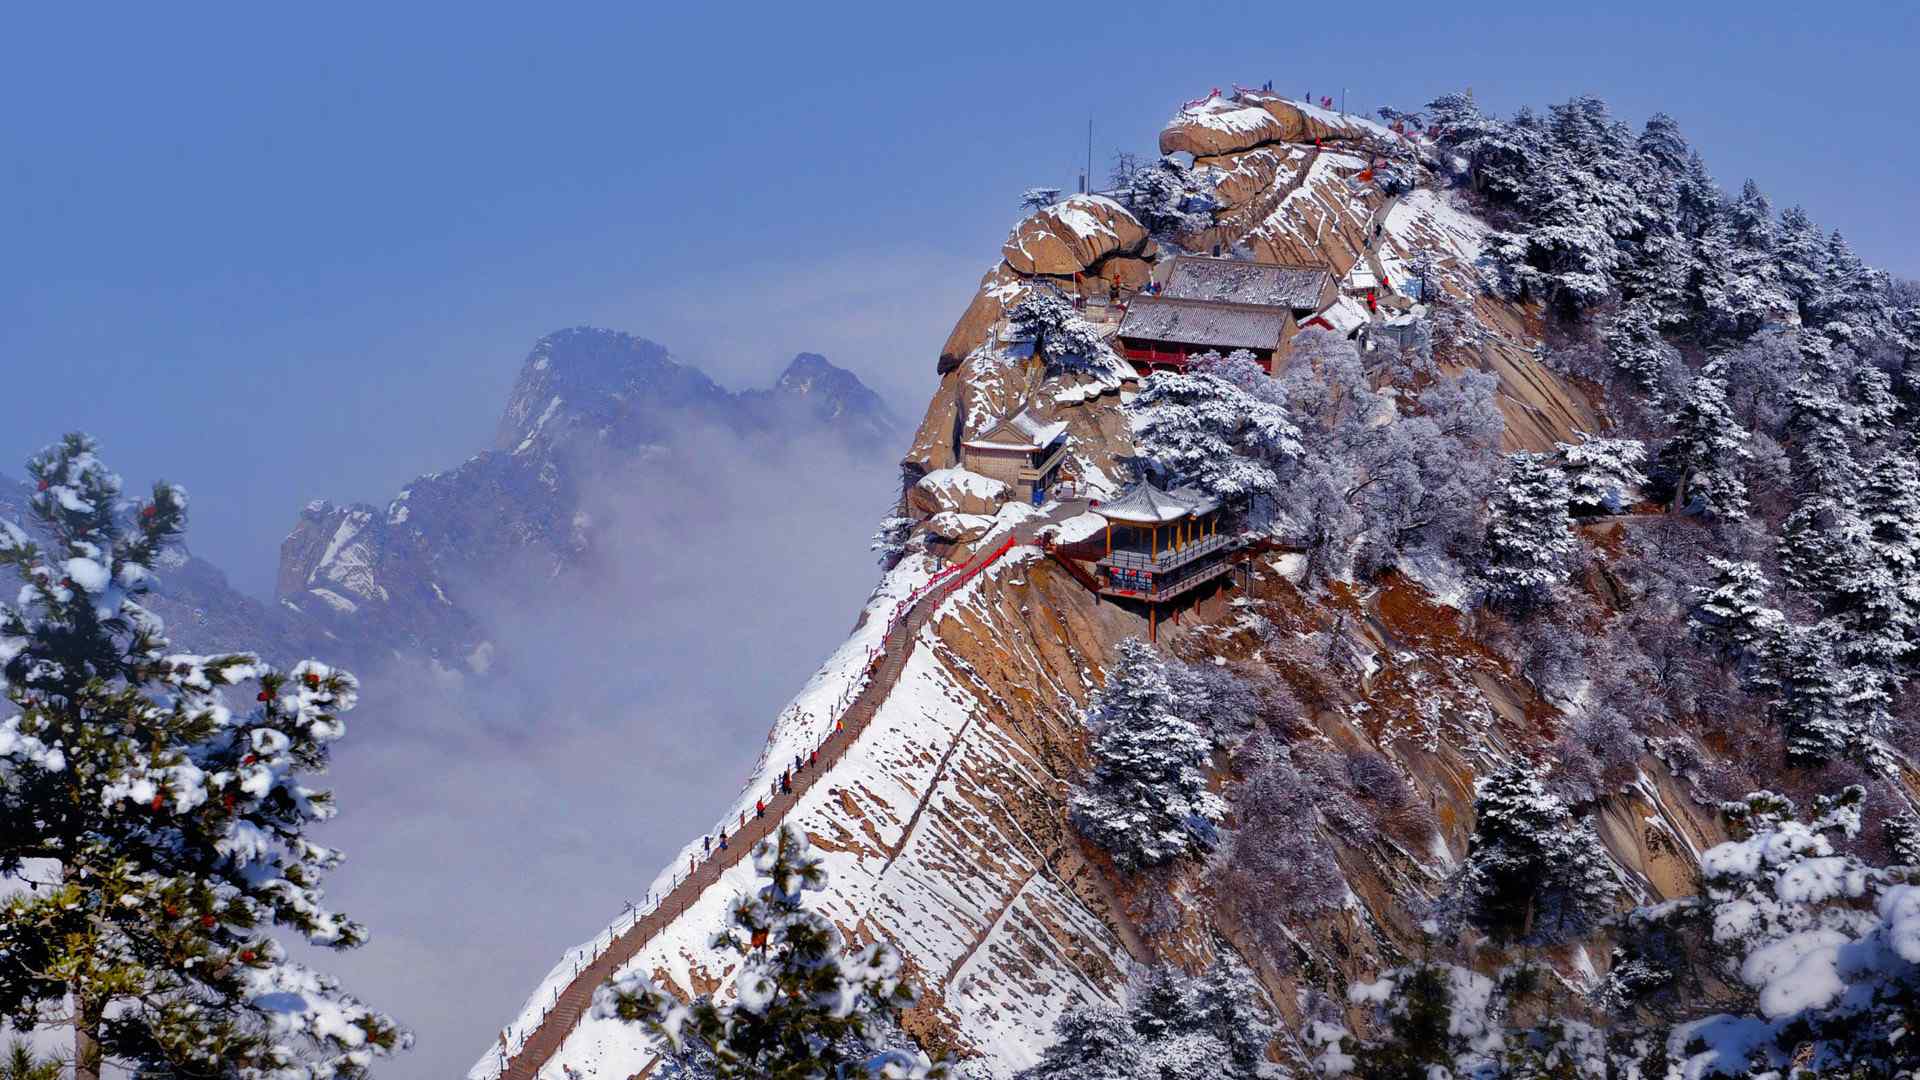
[1453,761,1620,944]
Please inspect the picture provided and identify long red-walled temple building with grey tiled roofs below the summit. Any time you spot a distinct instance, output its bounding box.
[1116,256,1338,375]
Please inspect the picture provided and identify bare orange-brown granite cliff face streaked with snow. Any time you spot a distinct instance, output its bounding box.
[483,94,1743,1080]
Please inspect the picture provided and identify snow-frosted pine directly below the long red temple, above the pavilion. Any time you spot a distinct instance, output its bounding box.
[1127,369,1300,503]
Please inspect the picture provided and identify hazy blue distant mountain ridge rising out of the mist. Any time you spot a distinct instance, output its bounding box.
[0,327,904,673]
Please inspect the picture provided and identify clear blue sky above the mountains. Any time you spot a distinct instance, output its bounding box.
[0,2,1920,592]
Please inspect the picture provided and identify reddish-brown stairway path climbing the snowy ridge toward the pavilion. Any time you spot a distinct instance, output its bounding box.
[501,500,1087,1080]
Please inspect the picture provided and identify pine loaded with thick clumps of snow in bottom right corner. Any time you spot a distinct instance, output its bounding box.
[1609,788,1920,1080]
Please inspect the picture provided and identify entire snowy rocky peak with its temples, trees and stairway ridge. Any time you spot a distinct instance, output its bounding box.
[476,82,1912,1080]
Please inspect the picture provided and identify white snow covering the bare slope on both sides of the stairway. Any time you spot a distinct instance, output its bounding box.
[468,545,1127,1080]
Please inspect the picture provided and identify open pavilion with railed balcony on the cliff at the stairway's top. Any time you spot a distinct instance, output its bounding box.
[1092,480,1246,636]
